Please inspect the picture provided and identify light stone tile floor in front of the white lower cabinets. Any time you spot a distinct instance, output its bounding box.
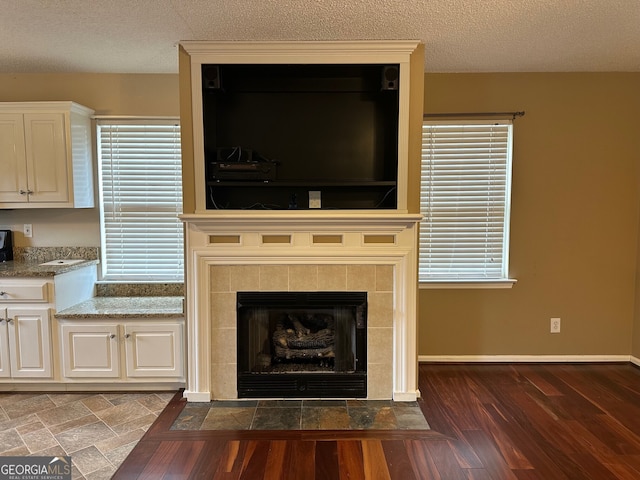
[0,392,175,480]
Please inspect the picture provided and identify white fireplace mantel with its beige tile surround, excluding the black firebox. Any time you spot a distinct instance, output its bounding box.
[182,211,420,402]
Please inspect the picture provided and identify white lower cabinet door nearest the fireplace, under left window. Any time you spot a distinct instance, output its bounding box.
[124,323,184,378]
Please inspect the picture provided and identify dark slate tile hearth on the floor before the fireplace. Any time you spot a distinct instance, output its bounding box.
[171,400,429,430]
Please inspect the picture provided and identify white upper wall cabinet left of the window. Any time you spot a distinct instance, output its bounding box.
[0,102,94,209]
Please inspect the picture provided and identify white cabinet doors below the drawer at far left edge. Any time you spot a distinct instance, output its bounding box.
[0,307,52,378]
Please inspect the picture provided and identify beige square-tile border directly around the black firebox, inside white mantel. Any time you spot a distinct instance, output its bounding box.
[211,265,393,398]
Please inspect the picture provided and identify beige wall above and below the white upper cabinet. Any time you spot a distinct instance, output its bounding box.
[0,74,179,247]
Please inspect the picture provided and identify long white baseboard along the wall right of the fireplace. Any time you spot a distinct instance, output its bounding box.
[418,355,640,366]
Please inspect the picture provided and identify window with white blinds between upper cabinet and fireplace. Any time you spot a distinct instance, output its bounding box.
[97,119,184,282]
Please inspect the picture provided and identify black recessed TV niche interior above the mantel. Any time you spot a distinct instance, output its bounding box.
[202,64,399,210]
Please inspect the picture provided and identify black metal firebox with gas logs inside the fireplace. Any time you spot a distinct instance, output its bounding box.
[237,292,367,398]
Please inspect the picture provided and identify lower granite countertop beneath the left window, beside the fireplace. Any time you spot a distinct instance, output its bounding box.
[55,297,184,319]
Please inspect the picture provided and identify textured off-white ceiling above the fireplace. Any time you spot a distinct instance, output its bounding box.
[0,0,640,73]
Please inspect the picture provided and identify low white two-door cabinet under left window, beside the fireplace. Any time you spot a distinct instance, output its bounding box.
[58,318,184,383]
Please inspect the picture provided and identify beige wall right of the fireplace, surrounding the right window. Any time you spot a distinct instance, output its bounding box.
[419,74,640,356]
